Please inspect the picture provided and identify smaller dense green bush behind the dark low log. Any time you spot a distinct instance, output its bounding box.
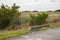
[30,13,48,25]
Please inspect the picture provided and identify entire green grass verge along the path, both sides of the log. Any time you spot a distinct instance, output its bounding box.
[0,22,60,40]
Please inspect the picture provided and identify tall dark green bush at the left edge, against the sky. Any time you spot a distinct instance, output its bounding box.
[0,4,20,29]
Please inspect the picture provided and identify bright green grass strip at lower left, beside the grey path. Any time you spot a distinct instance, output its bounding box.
[0,29,30,40]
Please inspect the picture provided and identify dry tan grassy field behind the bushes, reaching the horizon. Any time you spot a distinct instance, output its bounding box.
[21,12,60,22]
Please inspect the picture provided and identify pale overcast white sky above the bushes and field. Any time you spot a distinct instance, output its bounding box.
[0,0,60,11]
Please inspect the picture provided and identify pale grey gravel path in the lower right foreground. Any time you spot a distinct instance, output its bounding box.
[6,27,60,40]
